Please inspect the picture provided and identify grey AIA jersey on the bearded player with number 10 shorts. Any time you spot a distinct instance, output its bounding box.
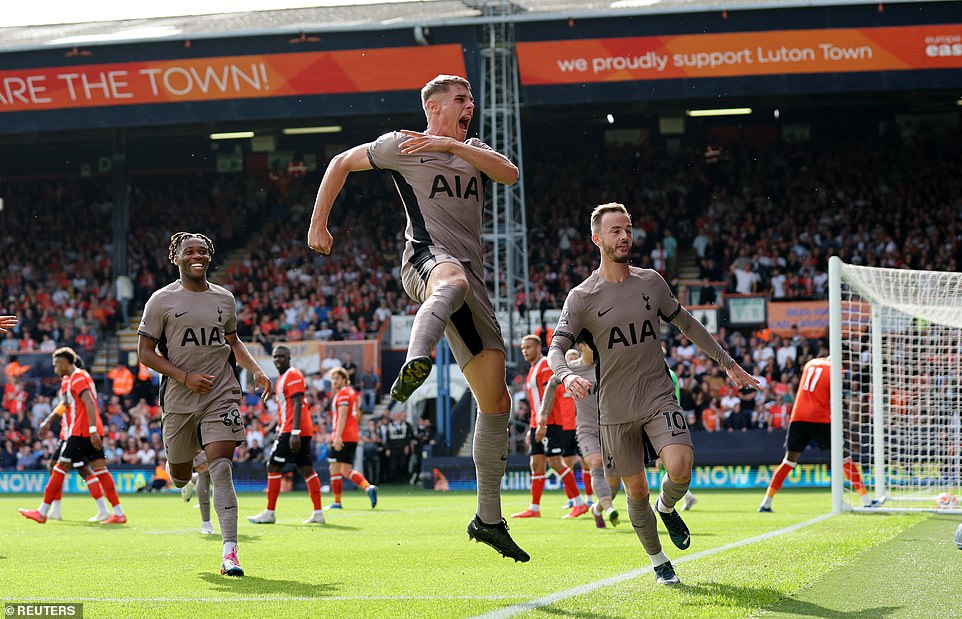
[549,267,681,425]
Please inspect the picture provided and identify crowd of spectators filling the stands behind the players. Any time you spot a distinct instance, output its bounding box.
[0,122,962,474]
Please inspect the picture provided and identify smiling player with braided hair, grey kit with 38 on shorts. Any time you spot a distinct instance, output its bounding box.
[137,232,271,576]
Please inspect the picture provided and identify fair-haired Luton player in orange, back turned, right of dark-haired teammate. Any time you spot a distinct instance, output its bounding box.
[327,368,377,509]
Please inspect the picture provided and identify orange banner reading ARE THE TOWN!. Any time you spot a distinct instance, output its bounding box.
[0,45,465,112]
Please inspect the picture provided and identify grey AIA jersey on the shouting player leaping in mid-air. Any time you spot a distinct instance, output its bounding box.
[367,131,491,273]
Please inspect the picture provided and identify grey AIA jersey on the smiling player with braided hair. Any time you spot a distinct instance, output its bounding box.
[137,280,241,413]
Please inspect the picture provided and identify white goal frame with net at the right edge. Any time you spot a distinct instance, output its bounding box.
[829,256,962,513]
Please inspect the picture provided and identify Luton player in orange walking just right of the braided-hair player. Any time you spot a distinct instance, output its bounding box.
[247,346,324,524]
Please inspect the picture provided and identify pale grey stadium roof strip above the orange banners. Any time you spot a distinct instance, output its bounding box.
[0,0,928,53]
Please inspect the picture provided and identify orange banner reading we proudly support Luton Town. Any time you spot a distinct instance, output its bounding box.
[517,24,962,86]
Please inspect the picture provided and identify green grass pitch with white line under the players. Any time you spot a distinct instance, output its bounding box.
[0,488,962,619]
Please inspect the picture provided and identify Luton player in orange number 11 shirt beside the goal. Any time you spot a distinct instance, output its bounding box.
[758,357,880,512]
